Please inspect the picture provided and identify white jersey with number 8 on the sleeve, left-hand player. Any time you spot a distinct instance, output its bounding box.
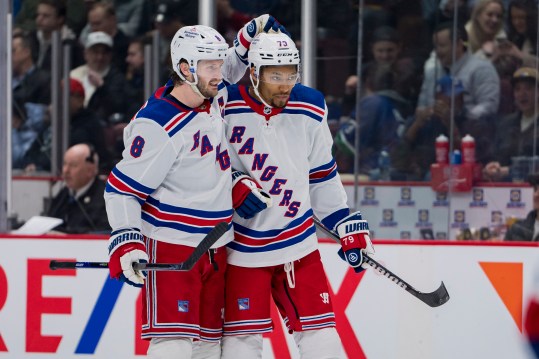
[105,54,245,248]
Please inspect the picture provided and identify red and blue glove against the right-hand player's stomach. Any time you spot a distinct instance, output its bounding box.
[232,171,272,219]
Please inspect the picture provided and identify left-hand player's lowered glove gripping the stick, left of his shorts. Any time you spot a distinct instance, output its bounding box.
[109,228,148,287]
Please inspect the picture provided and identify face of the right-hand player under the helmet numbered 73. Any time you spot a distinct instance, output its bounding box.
[258,65,299,107]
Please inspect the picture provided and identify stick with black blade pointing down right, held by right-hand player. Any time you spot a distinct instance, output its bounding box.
[313,217,449,307]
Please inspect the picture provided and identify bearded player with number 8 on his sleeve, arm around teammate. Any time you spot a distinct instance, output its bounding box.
[105,19,280,359]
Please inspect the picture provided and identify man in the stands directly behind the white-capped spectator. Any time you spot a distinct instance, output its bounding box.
[80,2,129,72]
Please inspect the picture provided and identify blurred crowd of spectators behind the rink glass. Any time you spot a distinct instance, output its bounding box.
[6,0,539,240]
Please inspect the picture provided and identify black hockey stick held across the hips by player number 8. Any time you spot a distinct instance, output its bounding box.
[49,222,228,271]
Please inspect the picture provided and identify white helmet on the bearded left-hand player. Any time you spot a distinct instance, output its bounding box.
[170,25,228,84]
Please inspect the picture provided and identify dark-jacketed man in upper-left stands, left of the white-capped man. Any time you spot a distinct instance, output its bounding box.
[30,0,81,71]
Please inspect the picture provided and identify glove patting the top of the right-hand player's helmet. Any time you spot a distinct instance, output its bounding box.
[234,14,290,61]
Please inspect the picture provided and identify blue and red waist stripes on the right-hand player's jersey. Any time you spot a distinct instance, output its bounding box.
[229,209,315,252]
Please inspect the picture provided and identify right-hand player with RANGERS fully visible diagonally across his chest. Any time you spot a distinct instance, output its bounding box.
[222,34,373,359]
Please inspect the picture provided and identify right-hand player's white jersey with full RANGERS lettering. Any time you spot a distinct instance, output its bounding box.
[224,84,349,267]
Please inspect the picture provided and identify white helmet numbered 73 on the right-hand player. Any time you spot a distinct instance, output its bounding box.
[249,33,299,77]
